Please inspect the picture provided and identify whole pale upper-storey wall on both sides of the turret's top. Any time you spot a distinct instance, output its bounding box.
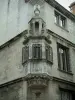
[0,0,75,45]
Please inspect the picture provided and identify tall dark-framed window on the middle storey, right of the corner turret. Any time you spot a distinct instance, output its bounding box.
[57,43,71,72]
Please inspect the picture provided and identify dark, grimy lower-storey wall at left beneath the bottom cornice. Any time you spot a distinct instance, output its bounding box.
[0,81,27,100]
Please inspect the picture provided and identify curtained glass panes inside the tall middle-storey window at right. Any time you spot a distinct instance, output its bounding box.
[57,44,70,71]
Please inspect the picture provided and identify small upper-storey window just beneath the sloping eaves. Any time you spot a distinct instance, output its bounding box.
[55,11,66,28]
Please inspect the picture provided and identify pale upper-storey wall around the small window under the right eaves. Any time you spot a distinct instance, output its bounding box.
[44,3,75,43]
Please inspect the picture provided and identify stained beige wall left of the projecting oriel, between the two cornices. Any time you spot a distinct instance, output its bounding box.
[0,37,24,84]
